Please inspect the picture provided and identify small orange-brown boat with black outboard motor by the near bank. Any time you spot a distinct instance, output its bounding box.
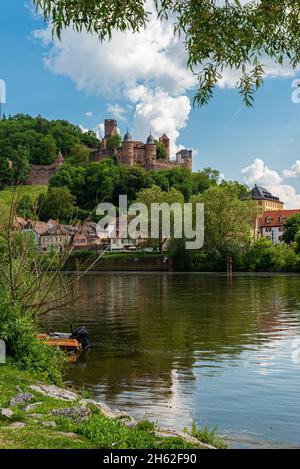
[37,326,91,353]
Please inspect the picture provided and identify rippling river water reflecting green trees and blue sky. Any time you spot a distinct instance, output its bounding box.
[44,272,300,448]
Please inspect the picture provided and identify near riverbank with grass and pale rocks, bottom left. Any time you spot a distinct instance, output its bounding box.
[0,365,226,449]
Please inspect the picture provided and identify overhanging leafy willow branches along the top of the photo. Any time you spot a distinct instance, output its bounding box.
[33,0,300,106]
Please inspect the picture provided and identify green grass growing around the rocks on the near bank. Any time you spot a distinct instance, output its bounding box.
[0,364,224,449]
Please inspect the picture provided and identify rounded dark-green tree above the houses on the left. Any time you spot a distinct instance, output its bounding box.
[38,187,76,223]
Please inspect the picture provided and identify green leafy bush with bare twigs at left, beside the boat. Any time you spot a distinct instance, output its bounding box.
[0,222,68,382]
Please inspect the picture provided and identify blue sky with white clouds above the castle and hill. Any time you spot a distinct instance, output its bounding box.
[0,0,300,208]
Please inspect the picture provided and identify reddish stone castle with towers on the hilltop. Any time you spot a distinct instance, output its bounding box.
[90,119,193,171]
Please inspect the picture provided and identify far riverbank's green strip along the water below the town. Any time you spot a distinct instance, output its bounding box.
[63,245,300,273]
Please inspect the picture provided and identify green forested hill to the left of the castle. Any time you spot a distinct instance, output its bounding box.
[0,114,99,188]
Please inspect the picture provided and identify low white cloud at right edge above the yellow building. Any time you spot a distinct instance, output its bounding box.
[241,159,300,209]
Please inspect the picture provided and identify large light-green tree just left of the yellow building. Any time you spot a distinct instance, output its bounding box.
[191,185,255,253]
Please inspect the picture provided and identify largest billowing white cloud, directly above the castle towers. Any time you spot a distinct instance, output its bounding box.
[34,0,196,156]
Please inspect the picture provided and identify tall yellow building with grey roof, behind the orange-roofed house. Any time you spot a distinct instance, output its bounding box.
[250,184,284,239]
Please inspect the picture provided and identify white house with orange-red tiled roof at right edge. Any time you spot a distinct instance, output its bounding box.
[260,210,300,244]
